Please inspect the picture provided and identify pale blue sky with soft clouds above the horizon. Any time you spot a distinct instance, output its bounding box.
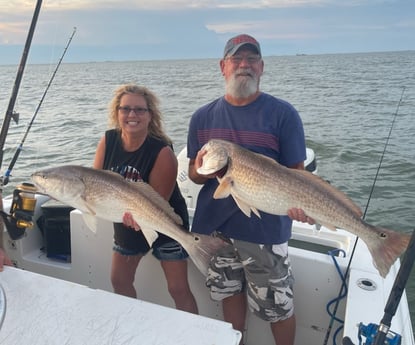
[0,0,415,64]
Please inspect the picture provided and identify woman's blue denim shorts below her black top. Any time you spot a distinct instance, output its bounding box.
[112,241,189,261]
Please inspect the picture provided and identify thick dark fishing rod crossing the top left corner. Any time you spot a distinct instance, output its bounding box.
[0,0,42,170]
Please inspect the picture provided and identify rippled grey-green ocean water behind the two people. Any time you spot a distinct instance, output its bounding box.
[0,51,415,329]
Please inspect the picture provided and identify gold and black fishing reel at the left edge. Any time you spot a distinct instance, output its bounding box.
[0,183,36,240]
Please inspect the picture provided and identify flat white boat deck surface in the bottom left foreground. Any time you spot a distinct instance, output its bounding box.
[0,267,241,345]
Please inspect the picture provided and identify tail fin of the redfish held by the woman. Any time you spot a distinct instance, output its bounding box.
[185,233,229,277]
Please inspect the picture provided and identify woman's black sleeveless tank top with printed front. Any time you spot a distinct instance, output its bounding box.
[103,129,189,249]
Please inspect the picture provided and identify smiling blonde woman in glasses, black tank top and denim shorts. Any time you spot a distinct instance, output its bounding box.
[94,84,198,314]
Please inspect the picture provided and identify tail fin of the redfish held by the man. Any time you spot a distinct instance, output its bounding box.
[366,226,411,278]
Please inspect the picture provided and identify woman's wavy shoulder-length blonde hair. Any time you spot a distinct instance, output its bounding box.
[108,84,172,145]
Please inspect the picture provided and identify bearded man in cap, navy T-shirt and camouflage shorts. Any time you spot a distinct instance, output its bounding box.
[187,34,312,345]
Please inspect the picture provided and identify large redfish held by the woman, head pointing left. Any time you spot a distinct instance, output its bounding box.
[32,165,228,275]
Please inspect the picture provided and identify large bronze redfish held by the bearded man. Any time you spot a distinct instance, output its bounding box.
[198,139,410,277]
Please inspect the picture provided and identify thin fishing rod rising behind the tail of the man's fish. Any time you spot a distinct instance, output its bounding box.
[323,86,405,345]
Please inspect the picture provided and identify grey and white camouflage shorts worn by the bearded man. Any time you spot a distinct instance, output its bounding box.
[206,240,294,322]
